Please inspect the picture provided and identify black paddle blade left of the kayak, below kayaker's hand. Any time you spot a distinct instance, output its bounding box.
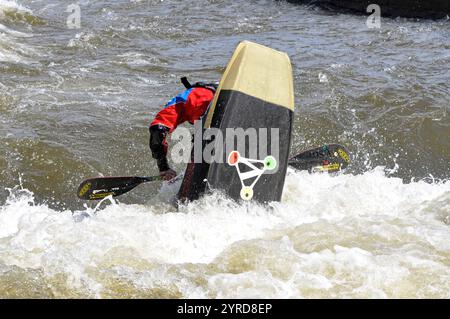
[77,176,161,200]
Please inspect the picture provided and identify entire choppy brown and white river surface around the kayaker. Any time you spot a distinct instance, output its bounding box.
[0,0,450,298]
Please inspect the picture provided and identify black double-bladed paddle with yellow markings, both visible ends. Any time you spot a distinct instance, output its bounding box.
[77,144,350,200]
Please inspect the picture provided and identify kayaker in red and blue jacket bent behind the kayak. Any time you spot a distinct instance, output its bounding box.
[149,77,218,181]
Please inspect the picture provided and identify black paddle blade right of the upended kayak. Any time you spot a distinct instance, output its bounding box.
[289,144,350,173]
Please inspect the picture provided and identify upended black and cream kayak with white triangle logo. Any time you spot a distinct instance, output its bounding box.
[178,41,294,203]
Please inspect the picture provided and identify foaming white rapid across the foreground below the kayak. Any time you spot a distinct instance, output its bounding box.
[0,167,450,298]
